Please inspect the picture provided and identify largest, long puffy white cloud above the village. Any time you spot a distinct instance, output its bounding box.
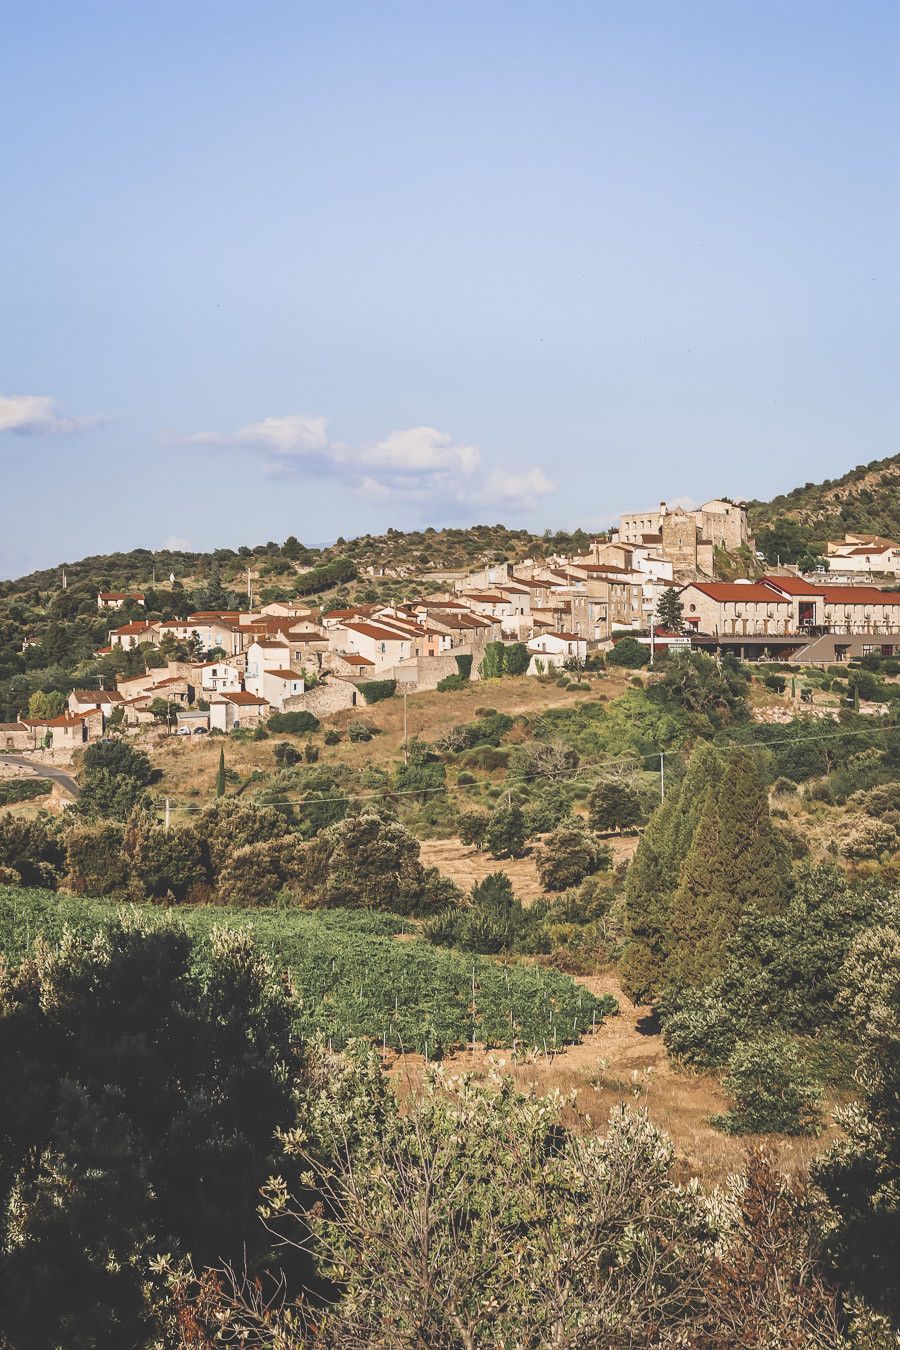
[181,413,555,510]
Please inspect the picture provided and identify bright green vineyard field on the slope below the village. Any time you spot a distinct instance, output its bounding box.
[0,887,617,1058]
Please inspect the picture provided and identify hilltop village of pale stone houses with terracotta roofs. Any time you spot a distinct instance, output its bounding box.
[0,498,900,757]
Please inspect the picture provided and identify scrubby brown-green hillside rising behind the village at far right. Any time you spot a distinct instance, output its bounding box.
[748,455,900,563]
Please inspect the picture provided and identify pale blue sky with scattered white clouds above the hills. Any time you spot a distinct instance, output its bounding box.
[0,0,900,575]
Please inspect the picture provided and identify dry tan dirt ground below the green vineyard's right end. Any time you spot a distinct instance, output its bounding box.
[389,972,827,1185]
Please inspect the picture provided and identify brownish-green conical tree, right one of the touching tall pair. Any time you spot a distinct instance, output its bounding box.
[667,751,787,986]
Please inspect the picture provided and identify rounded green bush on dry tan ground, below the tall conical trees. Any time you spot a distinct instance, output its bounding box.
[712,1035,822,1134]
